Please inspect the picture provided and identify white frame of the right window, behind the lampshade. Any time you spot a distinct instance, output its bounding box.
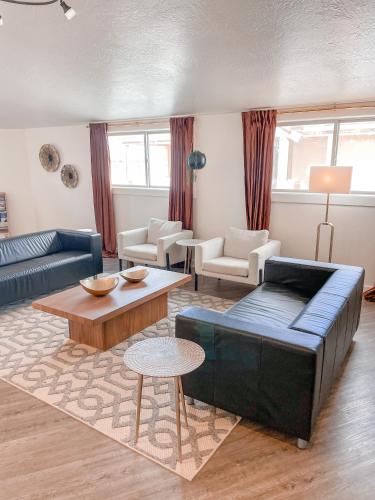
[272,116,375,196]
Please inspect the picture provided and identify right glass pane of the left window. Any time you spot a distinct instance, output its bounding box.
[148,132,171,187]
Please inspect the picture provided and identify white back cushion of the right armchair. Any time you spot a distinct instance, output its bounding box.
[224,227,269,260]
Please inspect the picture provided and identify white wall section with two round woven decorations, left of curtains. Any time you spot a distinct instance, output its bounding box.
[26,125,95,230]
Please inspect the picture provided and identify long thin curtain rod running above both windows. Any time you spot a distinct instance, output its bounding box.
[87,101,375,128]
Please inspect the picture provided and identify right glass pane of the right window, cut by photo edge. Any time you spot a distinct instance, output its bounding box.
[337,121,375,191]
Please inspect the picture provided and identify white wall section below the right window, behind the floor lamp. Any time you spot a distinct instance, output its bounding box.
[270,193,375,286]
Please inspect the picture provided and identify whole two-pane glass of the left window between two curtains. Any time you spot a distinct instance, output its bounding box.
[108,130,171,188]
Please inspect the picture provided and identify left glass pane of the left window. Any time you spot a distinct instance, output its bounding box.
[108,134,146,186]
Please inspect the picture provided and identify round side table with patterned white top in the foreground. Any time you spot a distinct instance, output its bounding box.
[124,337,205,462]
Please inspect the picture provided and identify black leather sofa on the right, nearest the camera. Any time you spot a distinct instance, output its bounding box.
[176,257,364,447]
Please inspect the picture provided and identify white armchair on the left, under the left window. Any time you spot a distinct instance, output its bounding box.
[117,219,193,270]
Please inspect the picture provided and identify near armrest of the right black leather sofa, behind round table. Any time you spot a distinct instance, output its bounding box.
[176,308,323,441]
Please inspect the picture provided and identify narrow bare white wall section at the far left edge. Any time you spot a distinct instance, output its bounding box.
[0,130,37,236]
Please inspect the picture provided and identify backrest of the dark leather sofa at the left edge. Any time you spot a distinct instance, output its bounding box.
[0,231,63,266]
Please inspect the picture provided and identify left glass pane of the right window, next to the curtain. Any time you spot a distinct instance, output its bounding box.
[272,123,334,189]
